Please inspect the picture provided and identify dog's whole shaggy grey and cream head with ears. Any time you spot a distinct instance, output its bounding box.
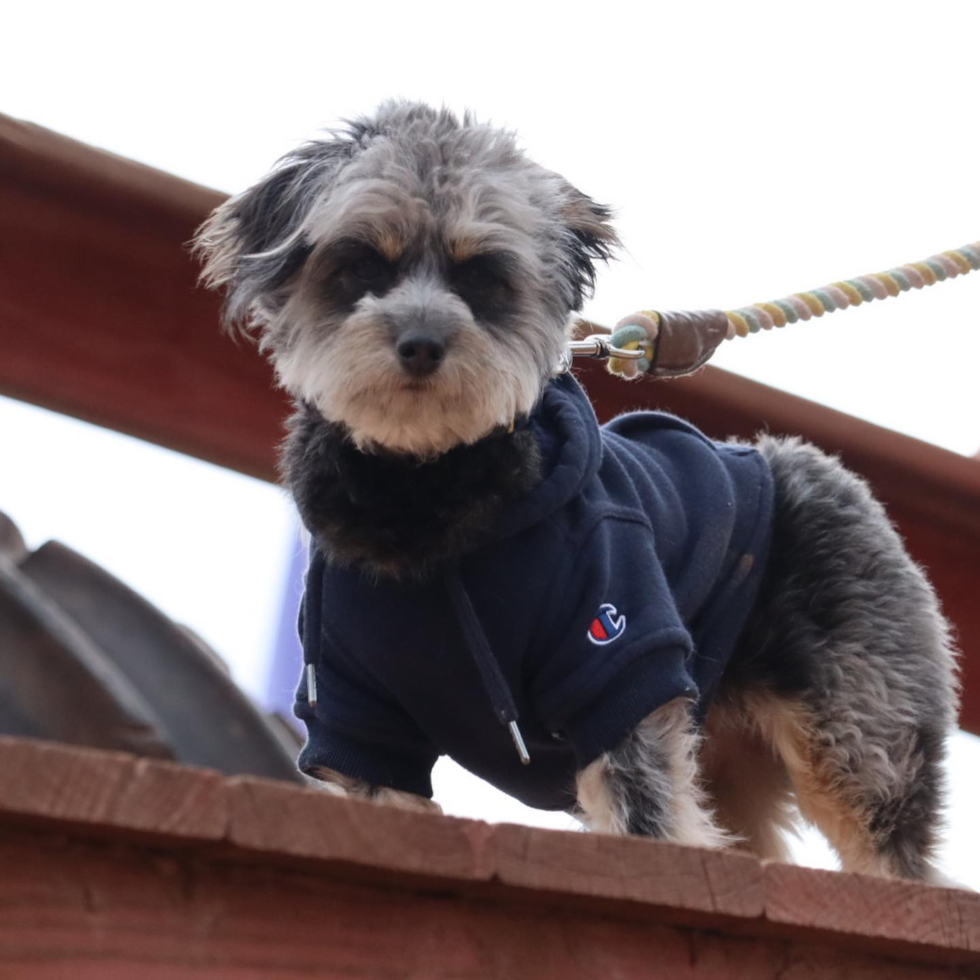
[197,103,617,457]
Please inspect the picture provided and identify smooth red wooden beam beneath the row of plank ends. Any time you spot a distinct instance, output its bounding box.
[0,834,977,980]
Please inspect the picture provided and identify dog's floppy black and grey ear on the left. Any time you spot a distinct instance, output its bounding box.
[193,138,355,327]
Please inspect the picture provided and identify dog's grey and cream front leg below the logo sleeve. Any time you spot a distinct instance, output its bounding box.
[577,698,732,847]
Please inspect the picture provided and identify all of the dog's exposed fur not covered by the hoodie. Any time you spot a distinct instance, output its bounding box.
[196,102,956,879]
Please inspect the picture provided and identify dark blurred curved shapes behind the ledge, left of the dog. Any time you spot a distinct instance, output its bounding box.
[0,513,301,782]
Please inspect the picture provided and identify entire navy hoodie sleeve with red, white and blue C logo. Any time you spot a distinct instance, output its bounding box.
[533,515,698,768]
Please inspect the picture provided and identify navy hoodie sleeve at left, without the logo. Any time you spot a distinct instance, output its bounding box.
[293,596,439,799]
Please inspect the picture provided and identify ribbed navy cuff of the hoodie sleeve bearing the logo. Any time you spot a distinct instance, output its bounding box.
[562,647,698,770]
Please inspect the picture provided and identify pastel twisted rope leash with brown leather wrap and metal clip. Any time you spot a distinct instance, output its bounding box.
[562,242,980,378]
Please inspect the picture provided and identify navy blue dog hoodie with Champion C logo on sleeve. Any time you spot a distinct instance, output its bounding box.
[295,374,772,810]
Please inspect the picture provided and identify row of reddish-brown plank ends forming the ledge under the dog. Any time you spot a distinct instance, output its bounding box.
[0,737,980,963]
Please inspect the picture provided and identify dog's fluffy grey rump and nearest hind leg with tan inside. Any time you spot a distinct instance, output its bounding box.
[721,438,956,880]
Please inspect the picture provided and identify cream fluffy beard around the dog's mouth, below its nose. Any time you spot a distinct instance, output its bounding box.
[273,310,557,458]
